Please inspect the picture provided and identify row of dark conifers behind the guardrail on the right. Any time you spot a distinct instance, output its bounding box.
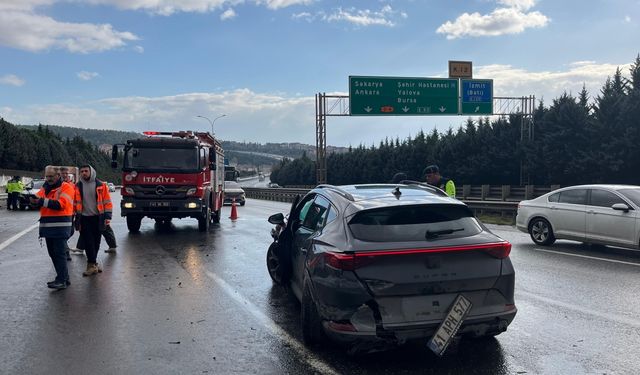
[271,55,640,185]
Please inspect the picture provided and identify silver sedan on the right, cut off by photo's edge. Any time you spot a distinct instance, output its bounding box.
[516,185,640,249]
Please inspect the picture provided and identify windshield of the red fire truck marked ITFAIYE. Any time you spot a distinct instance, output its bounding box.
[123,148,198,171]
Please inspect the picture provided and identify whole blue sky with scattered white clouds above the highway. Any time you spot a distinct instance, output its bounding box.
[0,0,640,146]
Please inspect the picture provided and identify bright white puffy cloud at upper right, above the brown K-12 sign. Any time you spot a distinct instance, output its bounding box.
[436,0,549,39]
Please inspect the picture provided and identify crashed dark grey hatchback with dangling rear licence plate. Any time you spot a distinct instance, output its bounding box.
[267,183,517,354]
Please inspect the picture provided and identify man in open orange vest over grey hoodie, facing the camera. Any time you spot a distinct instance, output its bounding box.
[75,165,113,276]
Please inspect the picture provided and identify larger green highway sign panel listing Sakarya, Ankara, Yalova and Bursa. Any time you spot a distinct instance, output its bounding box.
[349,76,458,116]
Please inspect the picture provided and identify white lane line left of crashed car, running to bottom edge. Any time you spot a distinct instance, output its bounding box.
[206,271,339,375]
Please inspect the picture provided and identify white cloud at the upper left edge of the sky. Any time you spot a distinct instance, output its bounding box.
[0,10,138,53]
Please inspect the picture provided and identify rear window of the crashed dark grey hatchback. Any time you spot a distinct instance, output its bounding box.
[349,204,482,242]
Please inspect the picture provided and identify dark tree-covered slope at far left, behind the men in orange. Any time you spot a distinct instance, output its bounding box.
[0,119,120,182]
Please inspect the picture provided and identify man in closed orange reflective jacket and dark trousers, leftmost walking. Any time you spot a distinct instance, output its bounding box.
[31,166,74,290]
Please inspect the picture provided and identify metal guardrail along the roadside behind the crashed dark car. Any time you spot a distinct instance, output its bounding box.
[243,187,524,218]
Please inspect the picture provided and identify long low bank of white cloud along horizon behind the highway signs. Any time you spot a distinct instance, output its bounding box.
[0,61,630,146]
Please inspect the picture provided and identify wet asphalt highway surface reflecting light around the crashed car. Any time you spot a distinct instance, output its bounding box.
[0,193,640,374]
